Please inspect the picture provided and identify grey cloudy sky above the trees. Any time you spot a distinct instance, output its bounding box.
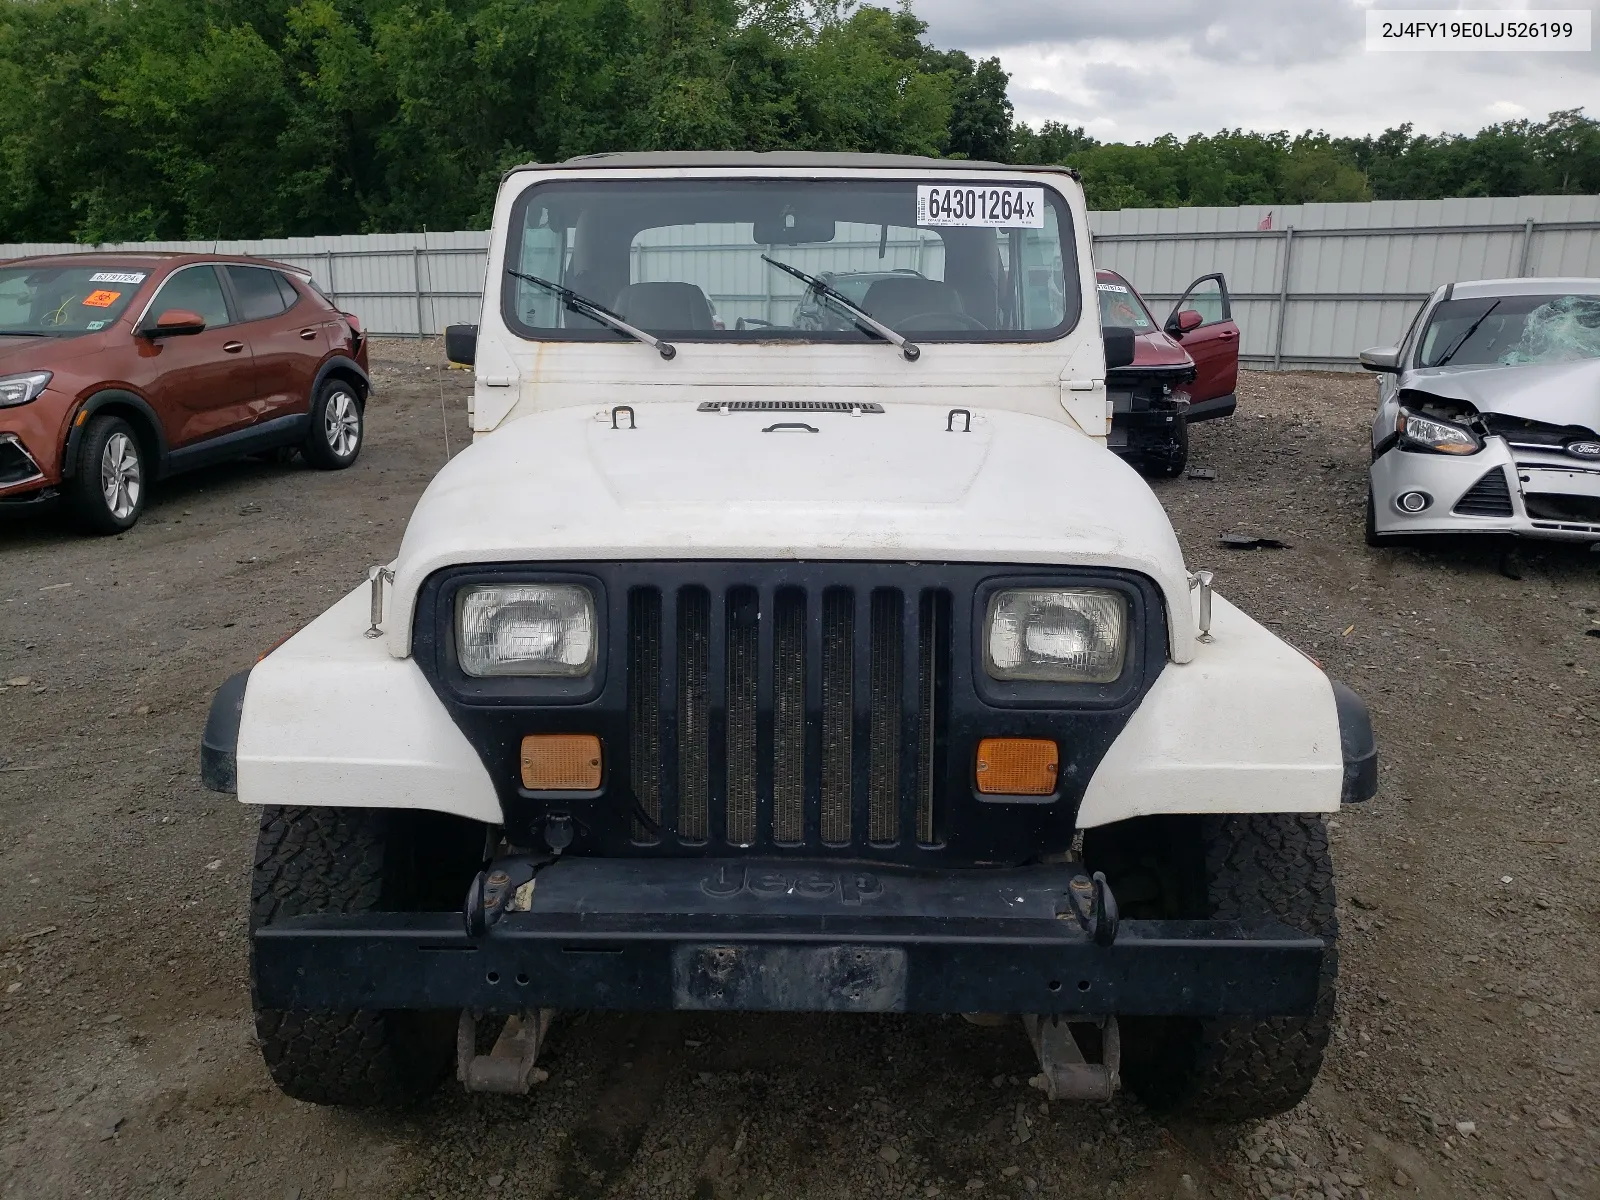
[912,0,1600,141]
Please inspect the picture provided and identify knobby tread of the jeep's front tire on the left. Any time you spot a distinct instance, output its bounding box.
[250,808,453,1107]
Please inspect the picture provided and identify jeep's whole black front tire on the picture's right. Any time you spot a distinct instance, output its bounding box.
[1100,813,1339,1122]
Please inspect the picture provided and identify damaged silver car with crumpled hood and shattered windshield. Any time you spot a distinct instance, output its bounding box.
[1362,278,1600,546]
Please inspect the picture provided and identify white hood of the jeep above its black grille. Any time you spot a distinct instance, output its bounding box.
[384,402,1192,661]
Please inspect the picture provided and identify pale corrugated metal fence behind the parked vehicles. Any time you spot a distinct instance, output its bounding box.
[0,195,1600,370]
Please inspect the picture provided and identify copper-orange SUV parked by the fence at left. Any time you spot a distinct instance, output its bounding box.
[0,253,371,533]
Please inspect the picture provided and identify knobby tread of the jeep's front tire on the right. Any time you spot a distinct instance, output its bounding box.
[1141,813,1339,1122]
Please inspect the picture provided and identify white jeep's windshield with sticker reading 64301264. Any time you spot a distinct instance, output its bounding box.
[504,179,1080,342]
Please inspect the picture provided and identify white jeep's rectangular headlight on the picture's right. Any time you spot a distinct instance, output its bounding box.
[984,587,1128,683]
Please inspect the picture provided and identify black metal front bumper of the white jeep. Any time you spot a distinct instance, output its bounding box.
[253,859,1323,1016]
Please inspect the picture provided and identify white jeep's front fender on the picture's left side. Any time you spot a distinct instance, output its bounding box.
[237,584,501,826]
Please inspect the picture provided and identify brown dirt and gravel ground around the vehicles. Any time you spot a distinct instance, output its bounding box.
[0,346,1600,1200]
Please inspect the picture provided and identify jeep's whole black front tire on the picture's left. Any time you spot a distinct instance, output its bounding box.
[250,808,482,1109]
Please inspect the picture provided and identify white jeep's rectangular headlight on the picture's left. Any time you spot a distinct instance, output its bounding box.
[456,584,597,678]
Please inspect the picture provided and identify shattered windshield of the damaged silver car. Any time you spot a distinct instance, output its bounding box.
[1416,296,1600,366]
